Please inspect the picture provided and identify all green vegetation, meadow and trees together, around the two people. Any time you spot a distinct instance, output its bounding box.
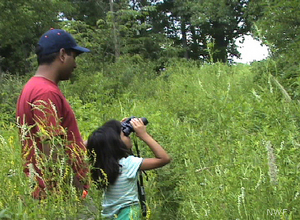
[0,0,300,220]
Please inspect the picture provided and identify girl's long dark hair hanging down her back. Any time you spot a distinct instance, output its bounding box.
[87,120,130,187]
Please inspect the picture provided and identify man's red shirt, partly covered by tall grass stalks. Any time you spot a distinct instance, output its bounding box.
[16,76,88,197]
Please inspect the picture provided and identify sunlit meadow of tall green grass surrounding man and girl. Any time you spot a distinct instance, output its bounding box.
[0,60,300,220]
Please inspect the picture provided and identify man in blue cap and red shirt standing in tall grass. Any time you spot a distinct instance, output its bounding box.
[16,29,90,199]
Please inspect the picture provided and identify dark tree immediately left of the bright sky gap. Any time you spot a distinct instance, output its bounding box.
[191,0,251,62]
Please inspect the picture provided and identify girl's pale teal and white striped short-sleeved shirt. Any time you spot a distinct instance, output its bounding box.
[102,155,143,218]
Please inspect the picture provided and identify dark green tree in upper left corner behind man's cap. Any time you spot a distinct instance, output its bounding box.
[0,0,72,74]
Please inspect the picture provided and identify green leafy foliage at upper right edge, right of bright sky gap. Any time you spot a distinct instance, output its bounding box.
[254,0,300,99]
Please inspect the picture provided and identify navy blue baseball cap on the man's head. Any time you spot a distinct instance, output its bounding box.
[38,29,90,55]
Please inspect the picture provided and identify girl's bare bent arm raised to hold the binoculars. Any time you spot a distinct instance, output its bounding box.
[130,118,171,170]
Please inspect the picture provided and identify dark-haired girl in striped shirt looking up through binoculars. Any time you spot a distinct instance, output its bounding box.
[87,118,171,220]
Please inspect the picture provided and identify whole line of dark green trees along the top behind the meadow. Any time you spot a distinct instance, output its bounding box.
[0,0,300,81]
